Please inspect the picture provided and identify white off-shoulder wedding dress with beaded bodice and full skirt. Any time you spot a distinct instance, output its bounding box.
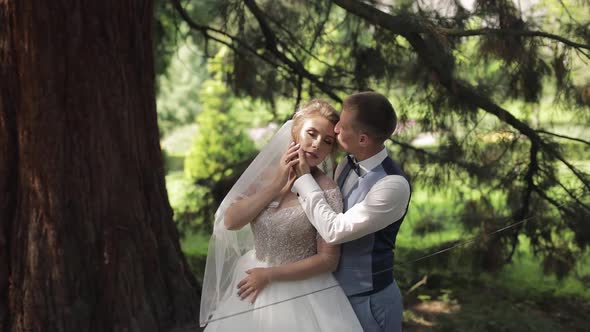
[205,189,362,332]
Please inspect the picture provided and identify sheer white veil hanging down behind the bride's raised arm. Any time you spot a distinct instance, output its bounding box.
[199,120,293,326]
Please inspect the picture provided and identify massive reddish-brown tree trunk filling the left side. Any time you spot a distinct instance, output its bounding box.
[0,0,199,332]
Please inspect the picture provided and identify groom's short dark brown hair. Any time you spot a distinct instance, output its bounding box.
[342,91,397,143]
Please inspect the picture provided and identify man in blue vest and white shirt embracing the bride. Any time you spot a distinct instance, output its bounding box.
[292,92,410,331]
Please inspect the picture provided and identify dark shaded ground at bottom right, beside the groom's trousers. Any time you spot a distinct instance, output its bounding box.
[404,279,590,332]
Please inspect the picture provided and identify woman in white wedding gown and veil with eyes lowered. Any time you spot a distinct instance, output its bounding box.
[200,100,362,332]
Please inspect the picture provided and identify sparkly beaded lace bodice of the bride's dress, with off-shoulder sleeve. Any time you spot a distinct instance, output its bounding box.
[251,188,342,265]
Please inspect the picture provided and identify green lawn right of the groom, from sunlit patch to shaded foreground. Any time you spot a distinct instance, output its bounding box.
[395,185,590,332]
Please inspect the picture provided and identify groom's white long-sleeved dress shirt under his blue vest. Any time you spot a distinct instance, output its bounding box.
[292,149,410,244]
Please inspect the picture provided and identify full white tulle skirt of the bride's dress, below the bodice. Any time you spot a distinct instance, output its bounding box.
[205,250,362,332]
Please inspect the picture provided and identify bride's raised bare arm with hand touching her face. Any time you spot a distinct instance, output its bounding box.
[223,144,299,230]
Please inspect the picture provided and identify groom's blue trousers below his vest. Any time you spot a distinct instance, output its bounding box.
[348,280,403,332]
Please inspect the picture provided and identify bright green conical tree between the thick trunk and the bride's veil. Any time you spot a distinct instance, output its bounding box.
[177,49,256,229]
